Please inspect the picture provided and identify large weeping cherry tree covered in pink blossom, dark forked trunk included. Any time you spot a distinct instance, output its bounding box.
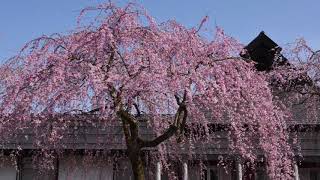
[0,3,293,180]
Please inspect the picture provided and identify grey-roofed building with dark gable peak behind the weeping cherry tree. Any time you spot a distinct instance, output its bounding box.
[0,32,320,180]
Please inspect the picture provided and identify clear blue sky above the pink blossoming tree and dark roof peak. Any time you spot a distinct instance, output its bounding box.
[0,0,320,64]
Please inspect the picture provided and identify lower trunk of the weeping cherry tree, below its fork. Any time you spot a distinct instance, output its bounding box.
[129,150,145,180]
